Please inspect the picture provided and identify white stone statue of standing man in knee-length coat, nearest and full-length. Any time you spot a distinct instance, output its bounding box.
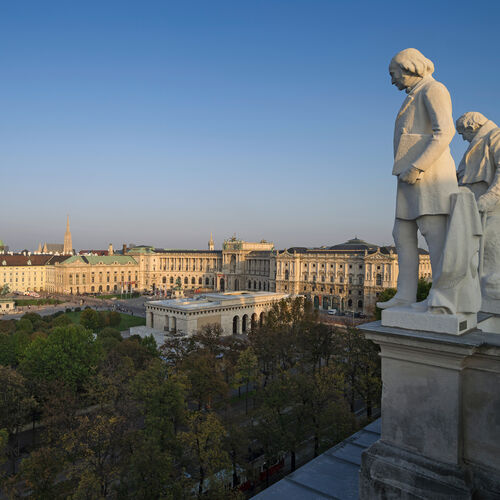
[377,49,458,309]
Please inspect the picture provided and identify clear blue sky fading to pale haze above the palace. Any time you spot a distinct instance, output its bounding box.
[0,0,500,250]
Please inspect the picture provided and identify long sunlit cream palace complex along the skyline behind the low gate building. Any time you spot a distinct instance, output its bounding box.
[13,225,432,313]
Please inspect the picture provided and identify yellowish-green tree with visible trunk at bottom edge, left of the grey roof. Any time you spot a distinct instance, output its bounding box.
[180,411,231,498]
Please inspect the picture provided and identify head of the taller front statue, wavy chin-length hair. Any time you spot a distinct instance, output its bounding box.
[389,49,434,90]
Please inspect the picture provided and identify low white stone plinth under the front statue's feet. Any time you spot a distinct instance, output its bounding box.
[382,307,477,335]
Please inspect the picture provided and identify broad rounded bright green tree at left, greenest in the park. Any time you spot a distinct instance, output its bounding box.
[20,325,102,389]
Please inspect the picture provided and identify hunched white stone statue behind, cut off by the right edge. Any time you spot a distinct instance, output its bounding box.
[456,112,500,313]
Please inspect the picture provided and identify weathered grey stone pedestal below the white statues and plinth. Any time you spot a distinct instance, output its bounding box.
[360,322,500,500]
